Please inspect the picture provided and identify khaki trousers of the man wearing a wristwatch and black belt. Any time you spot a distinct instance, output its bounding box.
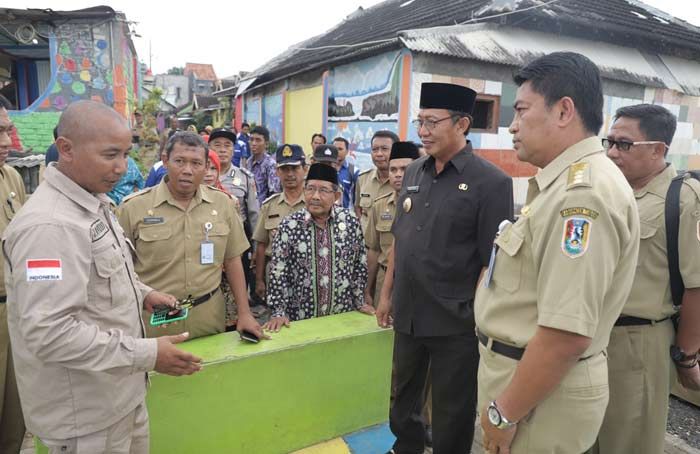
[478,343,608,454]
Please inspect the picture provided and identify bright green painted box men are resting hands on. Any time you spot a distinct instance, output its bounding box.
[38,312,393,454]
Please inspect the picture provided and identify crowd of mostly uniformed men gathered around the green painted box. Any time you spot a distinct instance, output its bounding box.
[0,49,700,454]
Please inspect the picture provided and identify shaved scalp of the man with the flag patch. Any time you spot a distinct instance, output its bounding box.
[56,101,130,144]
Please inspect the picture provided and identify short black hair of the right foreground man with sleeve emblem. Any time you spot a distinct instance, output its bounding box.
[513,52,603,134]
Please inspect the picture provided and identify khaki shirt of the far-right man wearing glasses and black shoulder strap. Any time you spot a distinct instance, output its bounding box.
[622,164,700,320]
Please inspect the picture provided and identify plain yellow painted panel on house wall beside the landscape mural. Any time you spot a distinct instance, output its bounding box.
[284,85,323,155]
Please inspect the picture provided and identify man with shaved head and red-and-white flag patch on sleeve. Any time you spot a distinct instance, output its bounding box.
[3,101,201,454]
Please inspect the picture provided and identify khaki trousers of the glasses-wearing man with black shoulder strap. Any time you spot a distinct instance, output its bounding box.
[590,320,675,454]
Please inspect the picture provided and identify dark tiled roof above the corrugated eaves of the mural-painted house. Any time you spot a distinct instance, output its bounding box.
[253,0,700,86]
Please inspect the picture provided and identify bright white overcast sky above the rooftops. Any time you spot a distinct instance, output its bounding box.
[2,0,700,78]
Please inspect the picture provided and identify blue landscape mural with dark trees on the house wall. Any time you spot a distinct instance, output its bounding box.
[326,51,410,169]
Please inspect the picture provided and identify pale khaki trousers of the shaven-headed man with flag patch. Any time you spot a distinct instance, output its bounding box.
[41,402,149,454]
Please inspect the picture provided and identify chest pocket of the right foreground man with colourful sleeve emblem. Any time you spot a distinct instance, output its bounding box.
[492,226,524,293]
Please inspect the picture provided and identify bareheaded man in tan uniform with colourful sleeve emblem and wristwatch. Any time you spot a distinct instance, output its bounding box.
[475,52,639,454]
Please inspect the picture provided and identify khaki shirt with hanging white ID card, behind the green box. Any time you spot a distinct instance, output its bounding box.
[117,179,249,298]
